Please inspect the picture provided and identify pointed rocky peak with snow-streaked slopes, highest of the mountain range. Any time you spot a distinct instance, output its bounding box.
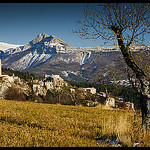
[1,33,69,70]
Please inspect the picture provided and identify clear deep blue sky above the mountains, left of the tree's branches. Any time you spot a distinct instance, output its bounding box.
[0,3,150,47]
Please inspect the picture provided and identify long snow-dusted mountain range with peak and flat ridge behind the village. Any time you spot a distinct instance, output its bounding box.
[0,33,149,81]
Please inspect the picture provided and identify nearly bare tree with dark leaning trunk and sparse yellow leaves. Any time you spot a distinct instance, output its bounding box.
[73,3,150,131]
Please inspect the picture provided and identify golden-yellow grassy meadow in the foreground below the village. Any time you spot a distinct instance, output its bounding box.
[0,100,150,147]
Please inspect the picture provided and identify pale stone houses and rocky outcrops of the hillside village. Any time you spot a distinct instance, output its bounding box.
[0,59,134,110]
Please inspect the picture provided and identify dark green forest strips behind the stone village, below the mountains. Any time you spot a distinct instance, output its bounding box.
[2,68,140,109]
